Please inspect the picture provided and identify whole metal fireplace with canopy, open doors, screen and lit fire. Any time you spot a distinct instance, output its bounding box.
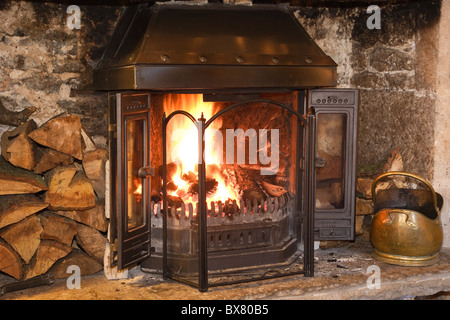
[94,4,358,291]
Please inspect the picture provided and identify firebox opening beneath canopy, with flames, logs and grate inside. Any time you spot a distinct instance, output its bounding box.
[141,92,301,278]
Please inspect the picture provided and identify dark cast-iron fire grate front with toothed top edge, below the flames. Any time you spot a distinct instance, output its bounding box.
[146,194,297,273]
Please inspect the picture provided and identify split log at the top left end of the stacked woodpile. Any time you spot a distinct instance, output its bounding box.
[1,120,37,170]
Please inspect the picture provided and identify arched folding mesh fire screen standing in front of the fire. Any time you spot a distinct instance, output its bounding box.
[158,95,314,291]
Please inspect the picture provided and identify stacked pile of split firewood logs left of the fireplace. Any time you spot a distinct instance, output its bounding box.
[0,115,108,280]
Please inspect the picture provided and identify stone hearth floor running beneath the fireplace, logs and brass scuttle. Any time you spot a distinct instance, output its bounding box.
[0,239,450,300]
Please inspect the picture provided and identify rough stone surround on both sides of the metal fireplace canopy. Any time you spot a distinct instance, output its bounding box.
[0,0,450,298]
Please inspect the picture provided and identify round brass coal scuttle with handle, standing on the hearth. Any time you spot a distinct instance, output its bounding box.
[370,171,443,266]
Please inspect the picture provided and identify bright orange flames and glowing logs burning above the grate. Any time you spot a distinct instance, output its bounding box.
[149,94,287,215]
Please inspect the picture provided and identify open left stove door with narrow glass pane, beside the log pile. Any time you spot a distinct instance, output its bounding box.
[115,93,150,269]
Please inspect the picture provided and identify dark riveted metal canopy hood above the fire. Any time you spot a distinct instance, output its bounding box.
[94,4,337,91]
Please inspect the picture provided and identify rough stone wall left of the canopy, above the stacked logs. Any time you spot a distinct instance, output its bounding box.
[0,1,122,143]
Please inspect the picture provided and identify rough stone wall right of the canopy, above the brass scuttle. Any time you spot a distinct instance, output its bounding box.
[297,2,440,179]
